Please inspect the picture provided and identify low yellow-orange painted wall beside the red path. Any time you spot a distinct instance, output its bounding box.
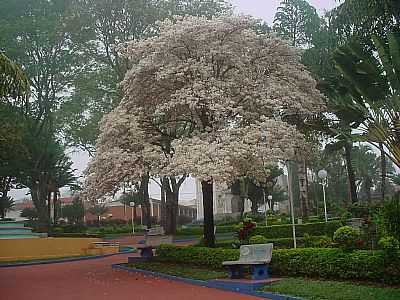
[0,238,118,261]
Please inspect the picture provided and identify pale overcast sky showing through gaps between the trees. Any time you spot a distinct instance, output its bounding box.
[11,0,338,204]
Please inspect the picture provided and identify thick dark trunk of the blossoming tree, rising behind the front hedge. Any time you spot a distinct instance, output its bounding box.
[201,180,215,248]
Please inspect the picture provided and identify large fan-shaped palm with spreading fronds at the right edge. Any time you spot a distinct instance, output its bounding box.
[334,33,400,198]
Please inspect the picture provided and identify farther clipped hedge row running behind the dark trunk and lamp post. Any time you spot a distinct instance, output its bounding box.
[177,221,342,238]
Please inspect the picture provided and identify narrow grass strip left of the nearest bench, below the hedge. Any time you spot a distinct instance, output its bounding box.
[128,261,228,280]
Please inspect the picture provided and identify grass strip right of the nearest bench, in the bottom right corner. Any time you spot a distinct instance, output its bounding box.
[264,278,400,300]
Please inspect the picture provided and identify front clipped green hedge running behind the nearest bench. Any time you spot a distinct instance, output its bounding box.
[157,245,400,284]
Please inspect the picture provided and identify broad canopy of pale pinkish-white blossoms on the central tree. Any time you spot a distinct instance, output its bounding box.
[83,16,324,199]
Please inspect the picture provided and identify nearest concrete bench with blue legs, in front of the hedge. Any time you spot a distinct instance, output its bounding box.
[222,244,274,280]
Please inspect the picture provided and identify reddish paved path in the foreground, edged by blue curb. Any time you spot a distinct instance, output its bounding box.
[0,254,259,300]
